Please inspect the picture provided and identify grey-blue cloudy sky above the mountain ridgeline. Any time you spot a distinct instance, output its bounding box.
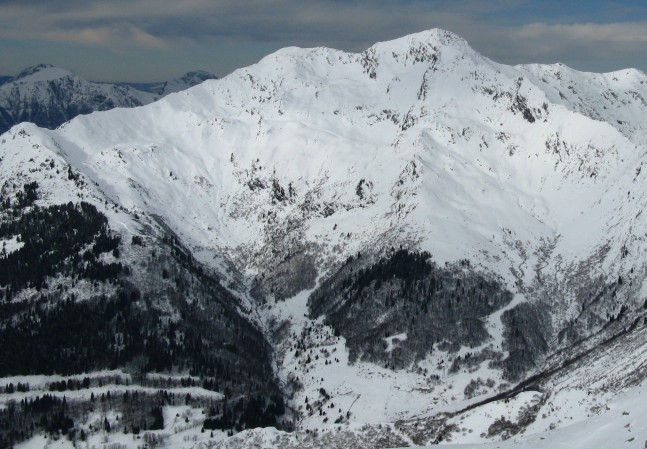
[0,0,647,82]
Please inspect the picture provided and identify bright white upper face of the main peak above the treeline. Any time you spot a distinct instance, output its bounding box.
[35,31,645,346]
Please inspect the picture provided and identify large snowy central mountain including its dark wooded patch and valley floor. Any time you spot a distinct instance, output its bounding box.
[0,30,647,447]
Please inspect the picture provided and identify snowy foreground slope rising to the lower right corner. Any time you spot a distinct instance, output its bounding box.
[144,327,647,449]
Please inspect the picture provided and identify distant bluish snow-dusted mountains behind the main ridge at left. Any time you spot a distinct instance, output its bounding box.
[0,64,215,133]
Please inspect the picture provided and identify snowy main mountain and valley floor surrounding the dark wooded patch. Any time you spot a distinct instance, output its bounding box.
[0,30,647,447]
